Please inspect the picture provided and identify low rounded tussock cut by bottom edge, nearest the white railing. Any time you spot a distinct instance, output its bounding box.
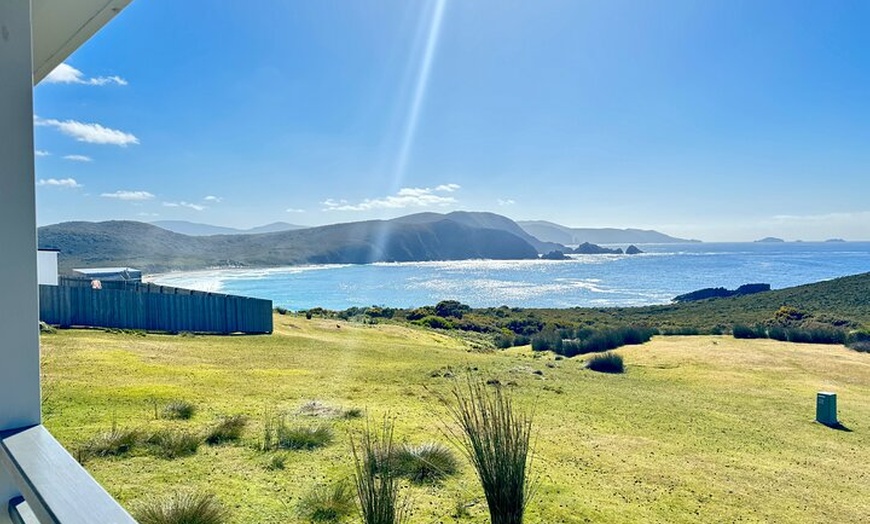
[133,492,229,524]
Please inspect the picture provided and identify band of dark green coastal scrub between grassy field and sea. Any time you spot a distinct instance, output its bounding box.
[328,273,870,350]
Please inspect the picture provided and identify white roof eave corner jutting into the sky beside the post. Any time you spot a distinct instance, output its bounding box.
[30,0,132,85]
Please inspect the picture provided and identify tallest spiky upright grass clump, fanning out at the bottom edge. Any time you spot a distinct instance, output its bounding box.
[444,377,533,524]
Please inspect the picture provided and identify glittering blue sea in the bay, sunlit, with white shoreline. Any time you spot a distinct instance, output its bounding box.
[150,242,870,310]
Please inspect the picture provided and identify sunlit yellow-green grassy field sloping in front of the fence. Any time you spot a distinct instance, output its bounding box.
[42,315,870,523]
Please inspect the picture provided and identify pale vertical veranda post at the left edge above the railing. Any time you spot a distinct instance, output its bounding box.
[0,0,40,523]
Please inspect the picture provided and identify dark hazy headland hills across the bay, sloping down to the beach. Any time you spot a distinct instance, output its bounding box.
[39,212,564,273]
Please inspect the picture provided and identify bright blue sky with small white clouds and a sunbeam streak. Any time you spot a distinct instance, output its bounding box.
[35,0,870,241]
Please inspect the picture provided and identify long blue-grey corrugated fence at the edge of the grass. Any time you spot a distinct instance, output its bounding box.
[39,281,272,334]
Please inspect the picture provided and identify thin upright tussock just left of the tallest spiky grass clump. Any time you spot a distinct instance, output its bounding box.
[351,418,410,524]
